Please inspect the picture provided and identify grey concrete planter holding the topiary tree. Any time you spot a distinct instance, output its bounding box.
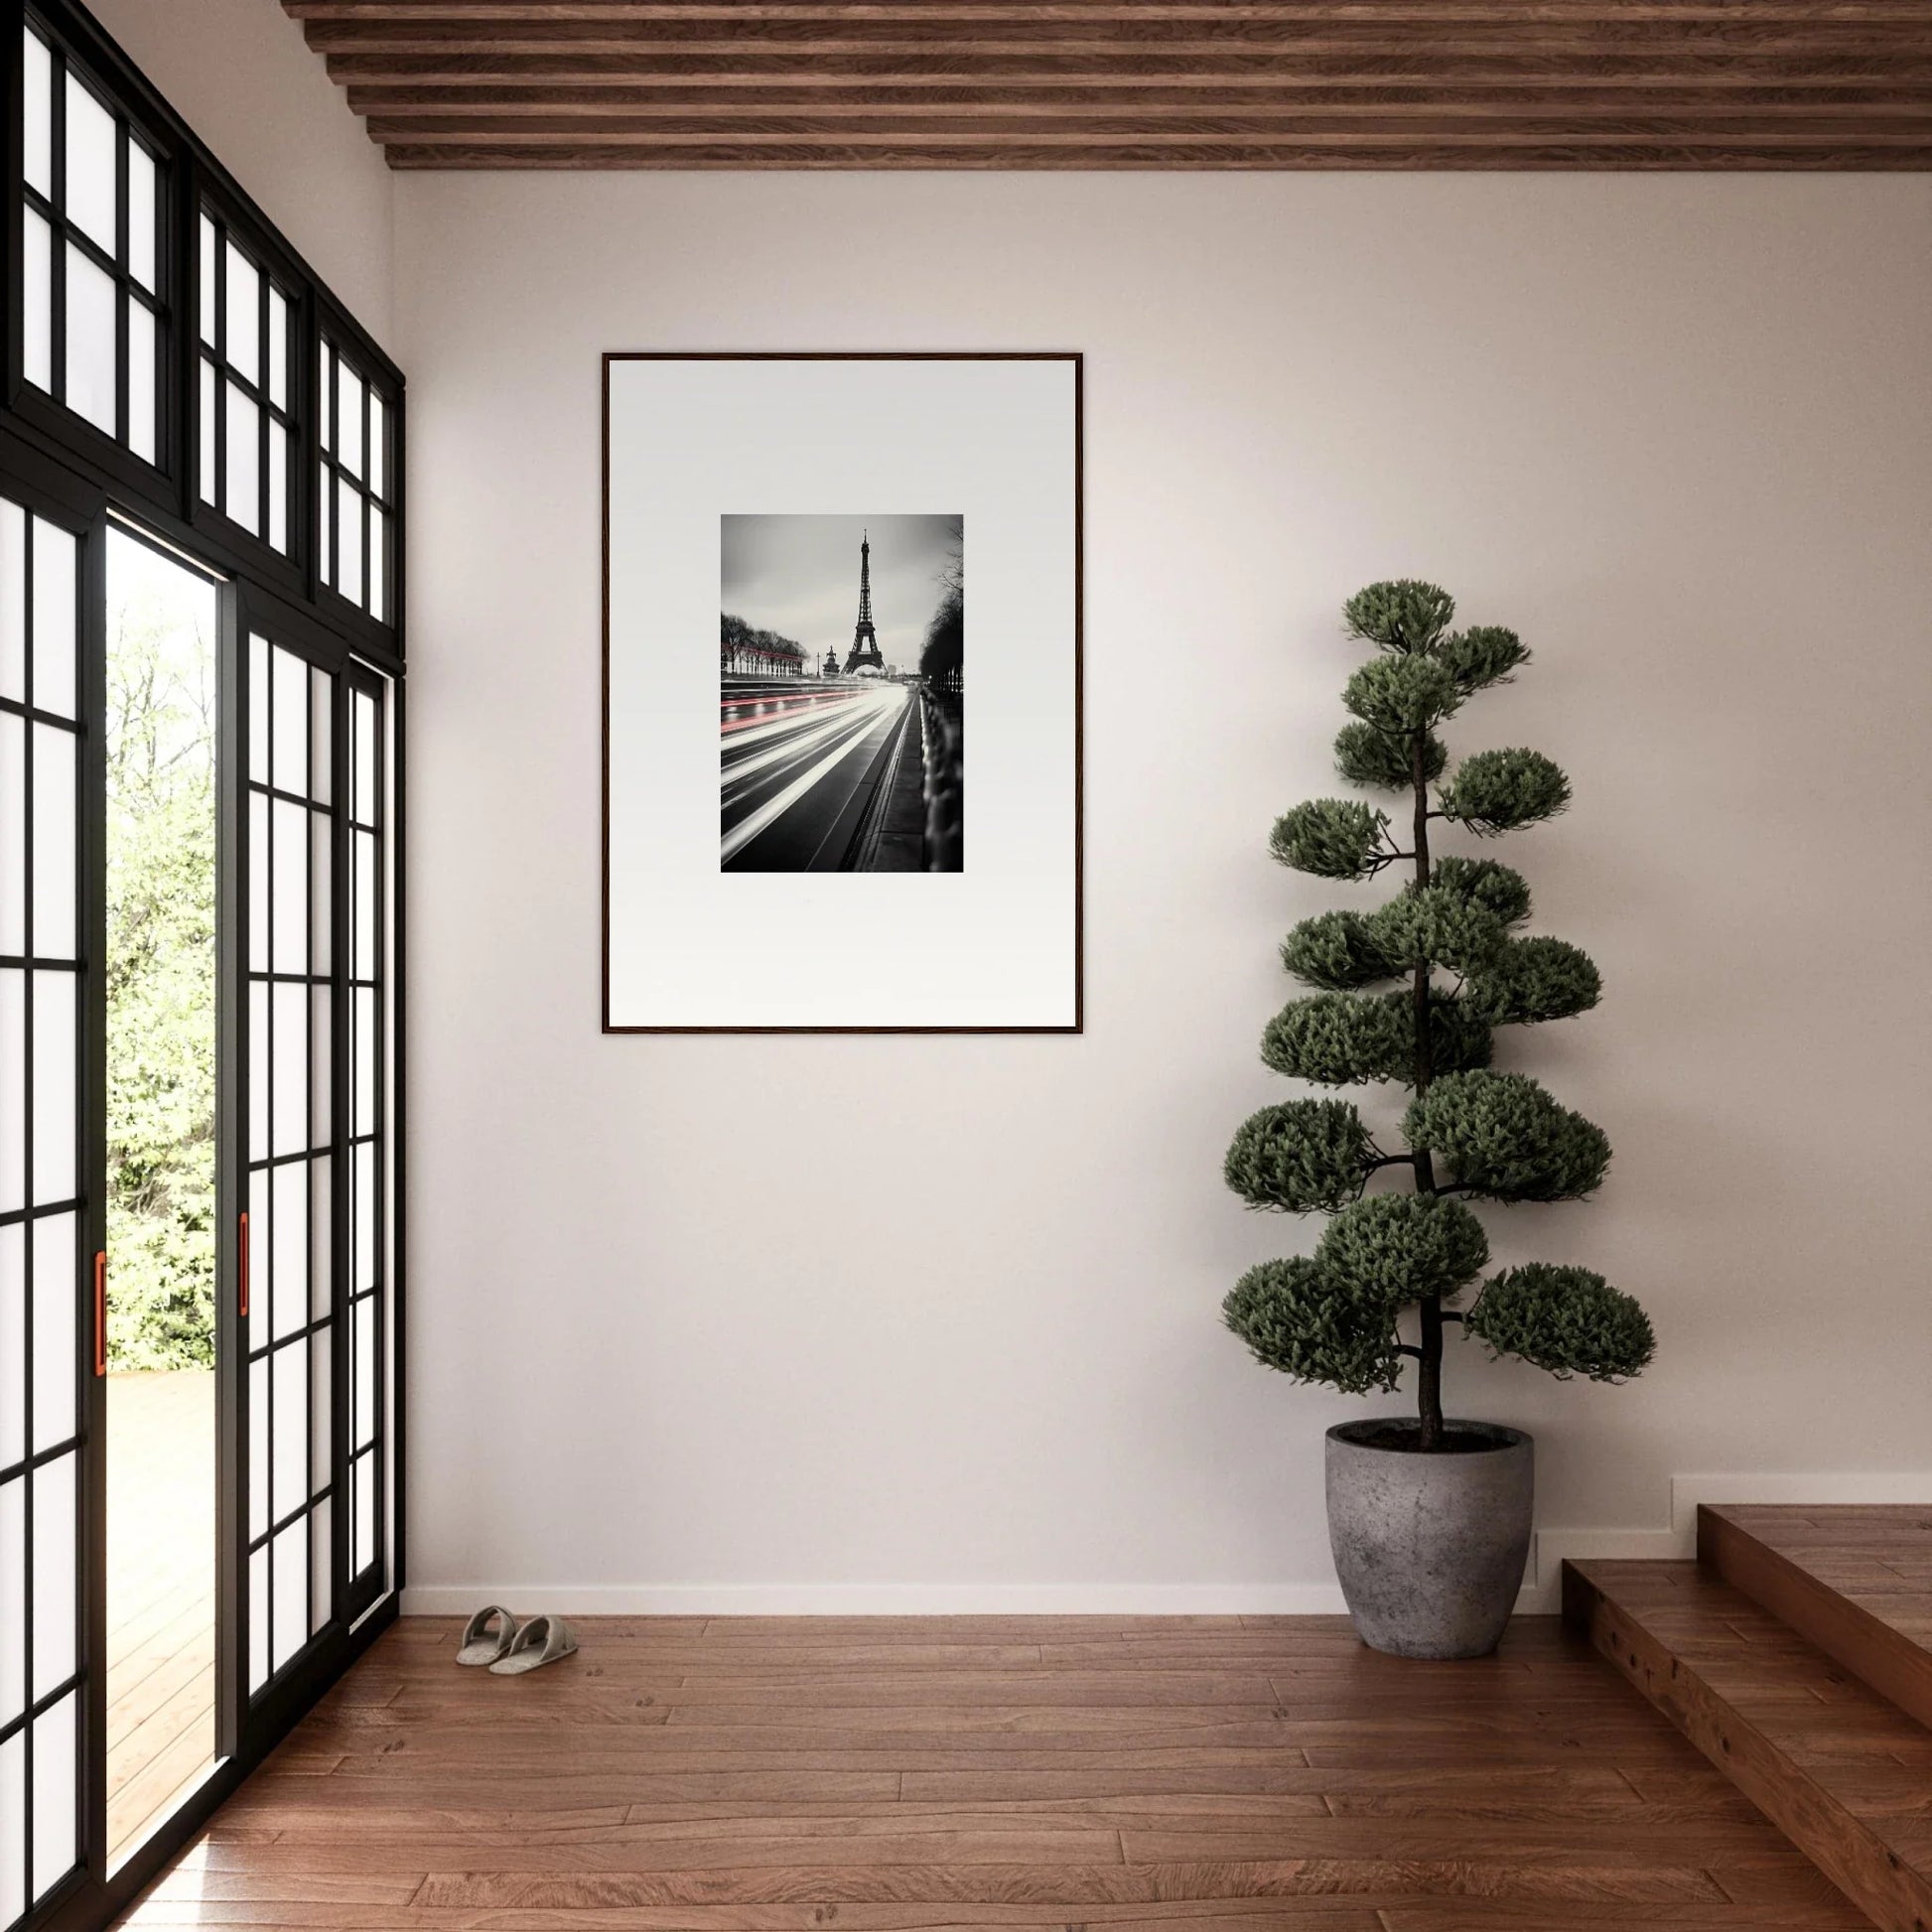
[1327,1418,1536,1658]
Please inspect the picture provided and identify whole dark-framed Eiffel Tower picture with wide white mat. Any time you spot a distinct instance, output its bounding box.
[603,353,1080,1034]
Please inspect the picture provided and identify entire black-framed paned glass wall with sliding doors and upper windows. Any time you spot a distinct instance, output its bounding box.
[0,0,406,1932]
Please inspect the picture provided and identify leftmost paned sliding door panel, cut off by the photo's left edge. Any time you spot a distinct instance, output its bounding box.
[0,483,102,1924]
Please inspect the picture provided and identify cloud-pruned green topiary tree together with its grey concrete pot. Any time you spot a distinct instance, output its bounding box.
[1223,580,1652,1658]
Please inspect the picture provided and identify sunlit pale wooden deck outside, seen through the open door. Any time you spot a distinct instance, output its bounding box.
[108,1370,214,1861]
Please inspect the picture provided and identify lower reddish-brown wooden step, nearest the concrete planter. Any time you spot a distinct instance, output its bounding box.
[1563,1561,1932,1932]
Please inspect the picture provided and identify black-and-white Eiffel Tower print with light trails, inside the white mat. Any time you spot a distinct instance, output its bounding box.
[719,514,966,874]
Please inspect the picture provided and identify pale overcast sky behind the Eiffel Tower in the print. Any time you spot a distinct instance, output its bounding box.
[719,516,962,670]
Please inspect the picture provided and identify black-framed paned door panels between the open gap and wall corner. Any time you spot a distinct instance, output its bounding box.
[228,621,390,1738]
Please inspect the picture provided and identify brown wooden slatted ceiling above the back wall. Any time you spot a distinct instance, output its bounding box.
[284,0,1932,170]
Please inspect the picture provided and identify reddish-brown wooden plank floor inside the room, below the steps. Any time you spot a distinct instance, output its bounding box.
[112,1617,1864,1932]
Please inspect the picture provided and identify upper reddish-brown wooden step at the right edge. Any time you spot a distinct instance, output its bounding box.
[1697,1503,1932,1725]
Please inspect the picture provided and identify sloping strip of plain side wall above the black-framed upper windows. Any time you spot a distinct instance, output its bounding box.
[87,0,394,351]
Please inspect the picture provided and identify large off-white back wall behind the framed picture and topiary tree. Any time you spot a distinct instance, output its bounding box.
[398,176,1932,1607]
